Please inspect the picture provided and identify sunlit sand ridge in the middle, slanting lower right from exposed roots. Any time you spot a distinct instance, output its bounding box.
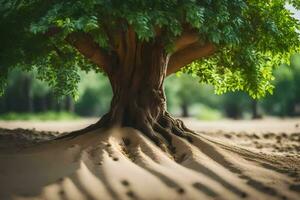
[120,129,238,199]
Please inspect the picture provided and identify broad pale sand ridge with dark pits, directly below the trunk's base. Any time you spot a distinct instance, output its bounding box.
[101,134,176,199]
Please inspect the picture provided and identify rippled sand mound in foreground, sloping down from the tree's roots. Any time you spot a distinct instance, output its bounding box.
[0,128,300,200]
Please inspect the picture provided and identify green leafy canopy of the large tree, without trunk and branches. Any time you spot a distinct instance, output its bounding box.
[0,0,300,98]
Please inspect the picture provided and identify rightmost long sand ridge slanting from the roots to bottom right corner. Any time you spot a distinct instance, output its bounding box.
[189,133,298,199]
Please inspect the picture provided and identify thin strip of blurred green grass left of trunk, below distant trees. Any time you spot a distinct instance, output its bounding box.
[0,112,80,121]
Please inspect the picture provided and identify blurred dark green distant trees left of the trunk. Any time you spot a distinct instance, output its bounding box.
[0,70,111,116]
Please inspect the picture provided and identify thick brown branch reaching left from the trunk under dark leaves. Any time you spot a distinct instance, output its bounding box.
[66,33,110,73]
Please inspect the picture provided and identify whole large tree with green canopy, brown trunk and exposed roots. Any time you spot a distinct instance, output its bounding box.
[0,0,300,148]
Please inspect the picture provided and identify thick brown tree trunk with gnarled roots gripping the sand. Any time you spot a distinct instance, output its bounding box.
[59,31,191,151]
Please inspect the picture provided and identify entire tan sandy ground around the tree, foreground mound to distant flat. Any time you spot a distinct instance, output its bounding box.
[0,119,300,200]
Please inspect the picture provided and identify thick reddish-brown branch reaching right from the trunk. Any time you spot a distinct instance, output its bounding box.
[167,42,216,75]
